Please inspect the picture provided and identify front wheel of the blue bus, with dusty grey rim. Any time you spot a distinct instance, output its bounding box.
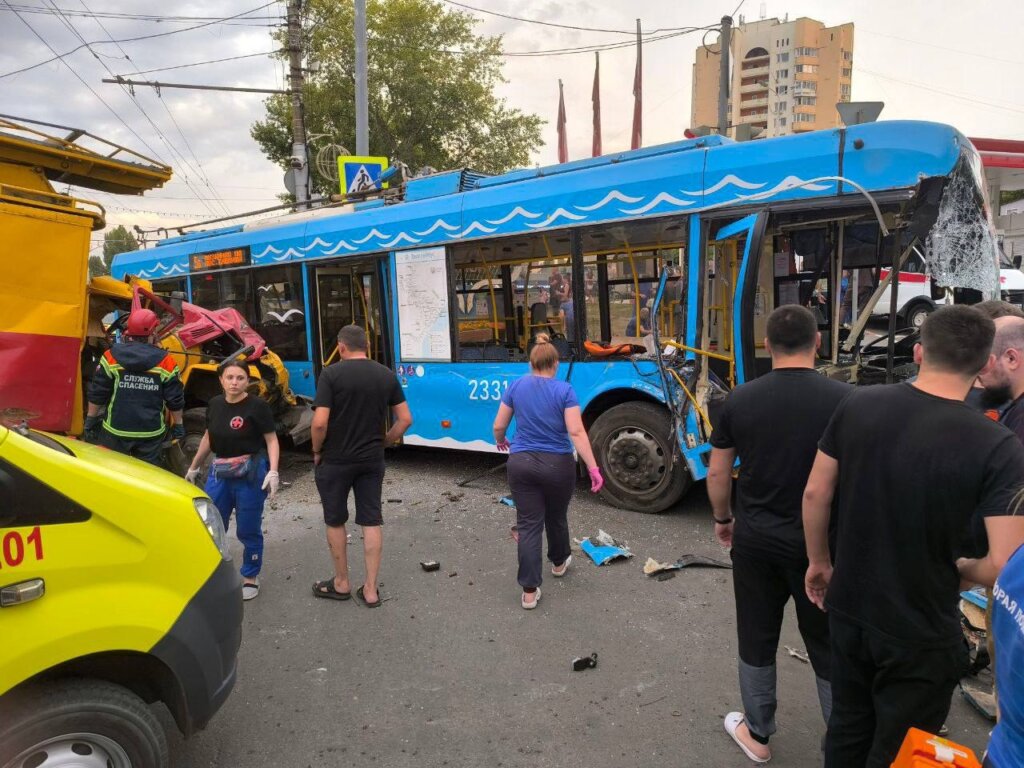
[590,402,691,514]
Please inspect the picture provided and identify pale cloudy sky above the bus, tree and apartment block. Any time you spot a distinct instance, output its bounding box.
[0,0,1024,256]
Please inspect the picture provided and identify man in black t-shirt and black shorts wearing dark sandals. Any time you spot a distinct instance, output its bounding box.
[311,326,413,607]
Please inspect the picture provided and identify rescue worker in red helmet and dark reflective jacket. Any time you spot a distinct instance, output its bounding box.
[85,309,185,467]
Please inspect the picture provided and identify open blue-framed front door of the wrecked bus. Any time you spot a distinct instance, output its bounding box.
[696,212,768,391]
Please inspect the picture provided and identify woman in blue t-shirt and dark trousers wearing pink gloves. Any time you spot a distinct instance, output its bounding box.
[495,334,604,610]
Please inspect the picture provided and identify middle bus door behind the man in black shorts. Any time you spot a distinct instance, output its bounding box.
[314,262,391,373]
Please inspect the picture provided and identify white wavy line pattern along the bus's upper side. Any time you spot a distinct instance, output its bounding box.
[155,173,829,276]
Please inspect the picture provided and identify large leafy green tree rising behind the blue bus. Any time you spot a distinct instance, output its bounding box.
[251,0,544,194]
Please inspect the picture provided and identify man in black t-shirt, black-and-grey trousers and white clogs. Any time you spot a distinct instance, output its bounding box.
[708,305,853,762]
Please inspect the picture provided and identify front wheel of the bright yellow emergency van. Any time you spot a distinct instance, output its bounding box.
[0,680,168,768]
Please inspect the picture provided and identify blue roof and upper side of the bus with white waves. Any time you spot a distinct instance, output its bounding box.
[113,121,973,279]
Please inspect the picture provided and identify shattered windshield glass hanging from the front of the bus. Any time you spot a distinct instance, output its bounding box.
[925,146,999,295]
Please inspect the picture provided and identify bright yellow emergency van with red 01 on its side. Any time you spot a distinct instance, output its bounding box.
[0,426,242,768]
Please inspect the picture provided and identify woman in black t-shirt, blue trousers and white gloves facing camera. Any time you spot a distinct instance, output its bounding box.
[185,359,281,600]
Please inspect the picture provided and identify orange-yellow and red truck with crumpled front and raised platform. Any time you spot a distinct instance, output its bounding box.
[0,116,308,473]
